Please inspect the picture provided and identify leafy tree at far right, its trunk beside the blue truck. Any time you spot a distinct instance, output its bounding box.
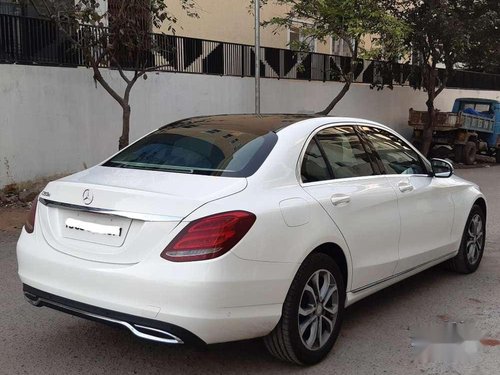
[384,0,498,154]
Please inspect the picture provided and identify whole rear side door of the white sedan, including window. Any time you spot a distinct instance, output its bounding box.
[301,126,400,291]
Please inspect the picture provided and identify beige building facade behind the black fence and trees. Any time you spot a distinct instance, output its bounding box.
[0,0,350,56]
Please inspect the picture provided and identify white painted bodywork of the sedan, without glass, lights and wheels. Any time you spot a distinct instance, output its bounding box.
[17,117,484,343]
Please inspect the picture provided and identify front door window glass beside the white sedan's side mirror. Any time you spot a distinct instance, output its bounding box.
[361,127,427,174]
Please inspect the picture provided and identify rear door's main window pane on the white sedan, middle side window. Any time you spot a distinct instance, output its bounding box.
[316,126,375,179]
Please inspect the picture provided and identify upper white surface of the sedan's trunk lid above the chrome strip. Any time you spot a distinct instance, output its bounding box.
[49,166,247,219]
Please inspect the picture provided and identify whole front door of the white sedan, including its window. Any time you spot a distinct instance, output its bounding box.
[359,126,456,273]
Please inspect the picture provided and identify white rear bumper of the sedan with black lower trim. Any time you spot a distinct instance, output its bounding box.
[17,228,297,344]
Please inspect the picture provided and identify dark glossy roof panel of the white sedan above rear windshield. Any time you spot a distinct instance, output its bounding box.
[161,114,319,136]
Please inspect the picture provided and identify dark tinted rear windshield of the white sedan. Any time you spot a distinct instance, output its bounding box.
[103,123,278,177]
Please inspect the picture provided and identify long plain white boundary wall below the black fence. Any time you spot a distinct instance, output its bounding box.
[0,65,500,187]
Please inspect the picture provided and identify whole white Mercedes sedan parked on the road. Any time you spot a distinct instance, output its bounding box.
[17,115,486,364]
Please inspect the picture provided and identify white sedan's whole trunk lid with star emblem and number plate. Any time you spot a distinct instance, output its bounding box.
[38,166,247,264]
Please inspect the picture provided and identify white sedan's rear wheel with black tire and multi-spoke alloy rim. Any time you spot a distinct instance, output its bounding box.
[264,253,345,365]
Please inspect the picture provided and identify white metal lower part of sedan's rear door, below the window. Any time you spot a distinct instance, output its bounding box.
[304,175,400,289]
